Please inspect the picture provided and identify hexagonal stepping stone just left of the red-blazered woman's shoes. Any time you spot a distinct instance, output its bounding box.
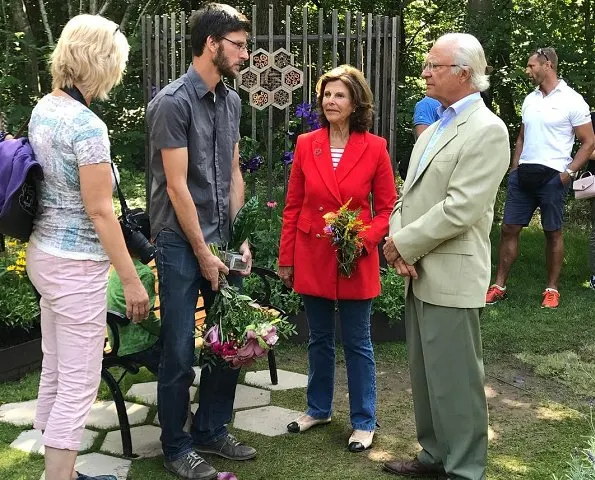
[233,406,302,437]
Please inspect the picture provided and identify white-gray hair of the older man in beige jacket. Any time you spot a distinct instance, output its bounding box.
[436,33,490,92]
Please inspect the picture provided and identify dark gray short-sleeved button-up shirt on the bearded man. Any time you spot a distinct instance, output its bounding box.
[146,65,242,244]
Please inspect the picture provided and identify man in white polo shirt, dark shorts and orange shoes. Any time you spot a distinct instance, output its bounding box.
[486,48,595,308]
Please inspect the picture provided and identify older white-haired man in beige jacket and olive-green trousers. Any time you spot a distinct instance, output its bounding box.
[384,34,510,480]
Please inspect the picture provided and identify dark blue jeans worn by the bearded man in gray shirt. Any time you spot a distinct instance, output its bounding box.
[156,229,240,461]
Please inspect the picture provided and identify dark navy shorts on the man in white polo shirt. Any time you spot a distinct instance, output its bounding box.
[504,169,570,232]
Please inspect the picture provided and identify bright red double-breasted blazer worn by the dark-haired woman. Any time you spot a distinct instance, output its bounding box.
[279,128,397,300]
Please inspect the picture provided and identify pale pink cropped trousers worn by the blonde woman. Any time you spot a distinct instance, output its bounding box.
[27,243,109,451]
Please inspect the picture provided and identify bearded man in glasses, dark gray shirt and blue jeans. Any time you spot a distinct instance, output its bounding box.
[147,3,256,479]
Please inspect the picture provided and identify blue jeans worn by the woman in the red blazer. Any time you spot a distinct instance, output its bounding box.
[303,295,376,431]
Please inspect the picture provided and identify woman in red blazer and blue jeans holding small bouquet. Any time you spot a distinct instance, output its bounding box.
[279,65,397,452]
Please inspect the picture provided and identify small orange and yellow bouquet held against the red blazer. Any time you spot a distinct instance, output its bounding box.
[322,198,368,277]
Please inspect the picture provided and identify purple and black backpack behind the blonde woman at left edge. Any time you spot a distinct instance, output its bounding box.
[0,137,43,241]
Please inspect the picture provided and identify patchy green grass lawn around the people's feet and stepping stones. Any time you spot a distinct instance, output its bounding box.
[0,229,595,480]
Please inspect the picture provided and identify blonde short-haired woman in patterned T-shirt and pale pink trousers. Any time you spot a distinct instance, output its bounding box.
[27,15,149,480]
